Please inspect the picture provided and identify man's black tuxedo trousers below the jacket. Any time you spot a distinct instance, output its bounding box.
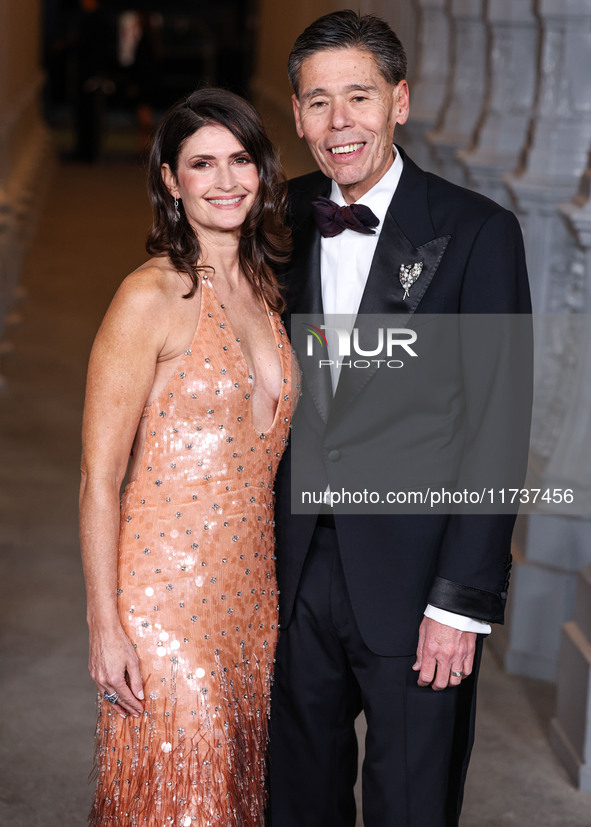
[267,528,482,827]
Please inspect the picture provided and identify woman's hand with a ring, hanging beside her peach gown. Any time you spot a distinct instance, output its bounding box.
[88,626,144,718]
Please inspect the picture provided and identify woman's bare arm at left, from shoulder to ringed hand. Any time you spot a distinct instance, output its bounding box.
[80,272,167,716]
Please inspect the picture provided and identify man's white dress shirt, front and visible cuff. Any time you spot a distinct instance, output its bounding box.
[320,149,491,634]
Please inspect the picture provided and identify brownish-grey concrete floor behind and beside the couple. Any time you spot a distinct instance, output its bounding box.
[0,158,591,827]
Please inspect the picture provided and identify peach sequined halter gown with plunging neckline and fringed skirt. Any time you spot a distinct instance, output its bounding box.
[90,277,291,827]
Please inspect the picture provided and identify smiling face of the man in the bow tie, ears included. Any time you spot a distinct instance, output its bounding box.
[292,48,409,204]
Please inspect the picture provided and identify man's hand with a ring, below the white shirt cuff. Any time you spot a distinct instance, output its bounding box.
[412,617,476,690]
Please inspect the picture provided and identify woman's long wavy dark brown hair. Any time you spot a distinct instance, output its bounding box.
[146,87,291,312]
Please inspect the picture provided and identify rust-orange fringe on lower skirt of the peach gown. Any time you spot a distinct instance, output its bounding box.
[89,661,271,827]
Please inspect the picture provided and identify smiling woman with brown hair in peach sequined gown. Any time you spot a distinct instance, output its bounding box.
[81,89,291,827]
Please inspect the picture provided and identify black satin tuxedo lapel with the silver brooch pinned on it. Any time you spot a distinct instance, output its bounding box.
[331,177,450,419]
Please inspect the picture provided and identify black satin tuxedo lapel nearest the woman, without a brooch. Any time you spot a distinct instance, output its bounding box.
[288,207,333,423]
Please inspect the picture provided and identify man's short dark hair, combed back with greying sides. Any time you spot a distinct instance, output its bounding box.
[287,9,406,97]
